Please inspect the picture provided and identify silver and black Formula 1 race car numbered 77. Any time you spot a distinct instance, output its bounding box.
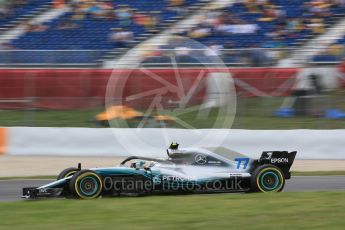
[22,143,296,199]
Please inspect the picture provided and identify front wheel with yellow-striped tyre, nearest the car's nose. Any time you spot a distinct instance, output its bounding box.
[69,170,103,200]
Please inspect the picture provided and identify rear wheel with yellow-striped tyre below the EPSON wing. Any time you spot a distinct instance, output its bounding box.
[251,165,285,193]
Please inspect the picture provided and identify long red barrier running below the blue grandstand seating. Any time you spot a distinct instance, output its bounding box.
[0,68,298,109]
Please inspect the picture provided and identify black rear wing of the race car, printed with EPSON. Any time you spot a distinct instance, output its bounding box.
[254,151,297,179]
